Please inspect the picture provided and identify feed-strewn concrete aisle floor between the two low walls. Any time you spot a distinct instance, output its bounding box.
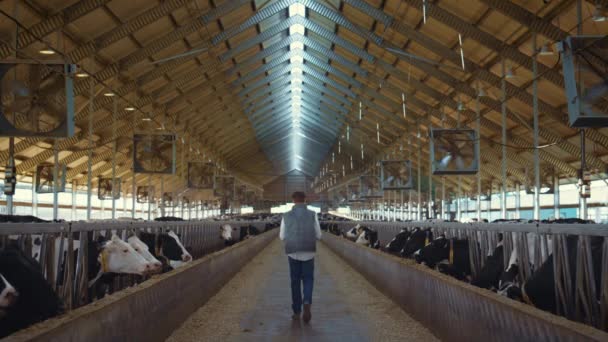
[167,240,436,342]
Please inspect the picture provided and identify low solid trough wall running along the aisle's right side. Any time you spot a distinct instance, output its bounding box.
[323,234,608,342]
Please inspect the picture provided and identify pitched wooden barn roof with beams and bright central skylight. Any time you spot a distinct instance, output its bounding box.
[0,0,608,200]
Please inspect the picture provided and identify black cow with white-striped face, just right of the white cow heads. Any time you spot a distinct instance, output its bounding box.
[139,231,192,272]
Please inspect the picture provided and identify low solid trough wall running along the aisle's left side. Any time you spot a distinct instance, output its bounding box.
[9,229,278,342]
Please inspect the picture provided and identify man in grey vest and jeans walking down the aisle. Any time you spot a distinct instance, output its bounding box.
[279,191,321,323]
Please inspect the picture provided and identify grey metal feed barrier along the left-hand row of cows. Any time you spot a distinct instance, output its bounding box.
[0,221,266,310]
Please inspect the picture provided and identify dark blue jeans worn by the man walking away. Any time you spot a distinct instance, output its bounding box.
[287,257,315,314]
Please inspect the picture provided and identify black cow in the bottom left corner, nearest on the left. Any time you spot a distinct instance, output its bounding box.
[0,248,64,338]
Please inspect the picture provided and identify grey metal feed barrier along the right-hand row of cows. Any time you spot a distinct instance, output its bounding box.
[324,221,608,330]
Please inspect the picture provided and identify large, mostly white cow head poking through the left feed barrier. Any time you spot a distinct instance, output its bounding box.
[97,234,151,275]
